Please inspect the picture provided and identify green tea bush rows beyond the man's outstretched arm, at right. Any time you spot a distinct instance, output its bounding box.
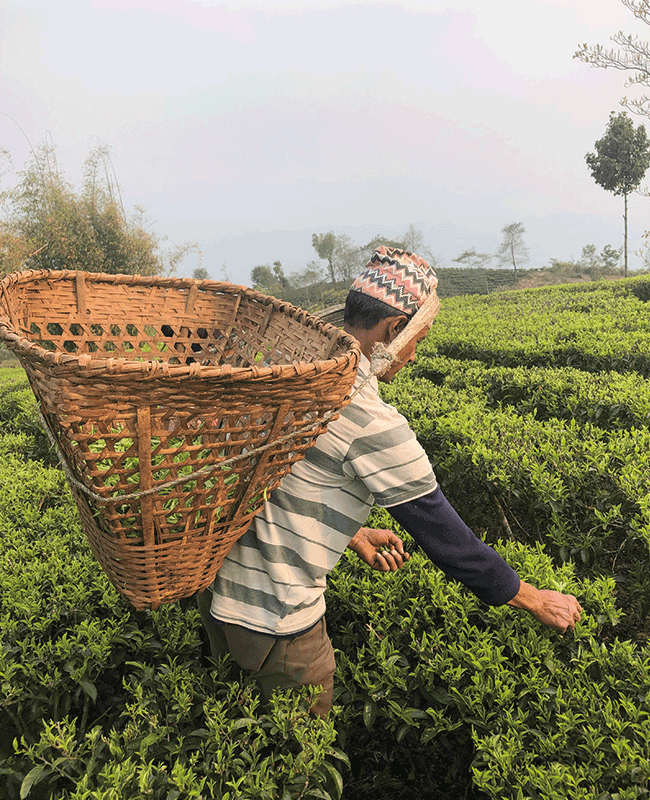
[383,279,650,616]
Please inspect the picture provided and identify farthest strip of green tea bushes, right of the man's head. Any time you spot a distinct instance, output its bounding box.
[420,276,650,377]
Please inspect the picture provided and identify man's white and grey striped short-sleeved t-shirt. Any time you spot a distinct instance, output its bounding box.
[211,356,437,636]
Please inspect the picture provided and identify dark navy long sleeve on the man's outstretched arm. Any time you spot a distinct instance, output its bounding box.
[387,486,520,606]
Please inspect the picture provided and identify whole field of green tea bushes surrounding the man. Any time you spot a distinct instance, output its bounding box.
[0,278,650,800]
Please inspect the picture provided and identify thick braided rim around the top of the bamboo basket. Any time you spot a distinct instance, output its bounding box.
[0,269,361,381]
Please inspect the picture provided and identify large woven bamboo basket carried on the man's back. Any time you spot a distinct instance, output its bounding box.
[0,270,359,608]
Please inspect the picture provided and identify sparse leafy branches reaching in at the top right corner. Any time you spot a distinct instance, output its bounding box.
[573,0,650,116]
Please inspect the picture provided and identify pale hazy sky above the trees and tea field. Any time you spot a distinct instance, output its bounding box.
[0,0,650,283]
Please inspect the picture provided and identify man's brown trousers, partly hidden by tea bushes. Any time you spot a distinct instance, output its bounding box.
[196,590,336,716]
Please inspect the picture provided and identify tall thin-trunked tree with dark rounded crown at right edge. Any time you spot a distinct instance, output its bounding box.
[585,111,650,277]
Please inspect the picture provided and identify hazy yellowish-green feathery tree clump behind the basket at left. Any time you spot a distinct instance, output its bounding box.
[0,145,198,275]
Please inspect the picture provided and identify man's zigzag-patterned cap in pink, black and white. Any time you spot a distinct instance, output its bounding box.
[350,245,438,315]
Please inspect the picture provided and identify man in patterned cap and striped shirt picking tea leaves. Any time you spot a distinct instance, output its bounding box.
[198,247,582,715]
